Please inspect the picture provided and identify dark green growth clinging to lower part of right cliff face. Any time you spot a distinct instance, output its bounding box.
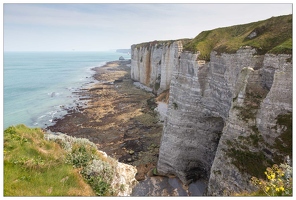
[226,112,292,178]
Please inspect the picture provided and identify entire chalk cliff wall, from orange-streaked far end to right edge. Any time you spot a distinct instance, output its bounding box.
[131,14,292,196]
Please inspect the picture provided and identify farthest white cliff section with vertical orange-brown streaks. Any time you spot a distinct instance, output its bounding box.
[131,41,182,94]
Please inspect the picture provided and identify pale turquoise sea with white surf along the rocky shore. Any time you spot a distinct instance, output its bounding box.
[3,51,130,129]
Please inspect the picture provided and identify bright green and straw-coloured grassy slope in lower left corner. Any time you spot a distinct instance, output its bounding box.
[4,125,95,196]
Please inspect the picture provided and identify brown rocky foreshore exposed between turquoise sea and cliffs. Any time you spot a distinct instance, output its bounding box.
[45,59,163,181]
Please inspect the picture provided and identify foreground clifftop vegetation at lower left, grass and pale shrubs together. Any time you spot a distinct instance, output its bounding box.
[4,125,123,196]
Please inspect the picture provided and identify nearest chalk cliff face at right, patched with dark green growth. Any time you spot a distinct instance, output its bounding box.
[208,55,292,195]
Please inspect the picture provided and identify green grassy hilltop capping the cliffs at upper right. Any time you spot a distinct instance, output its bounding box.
[184,15,292,61]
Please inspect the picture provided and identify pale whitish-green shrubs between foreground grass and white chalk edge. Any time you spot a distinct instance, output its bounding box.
[46,134,117,196]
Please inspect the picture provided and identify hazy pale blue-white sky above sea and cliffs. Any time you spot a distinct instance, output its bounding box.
[3,3,292,51]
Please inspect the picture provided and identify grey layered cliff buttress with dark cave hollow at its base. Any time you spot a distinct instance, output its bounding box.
[158,50,266,183]
